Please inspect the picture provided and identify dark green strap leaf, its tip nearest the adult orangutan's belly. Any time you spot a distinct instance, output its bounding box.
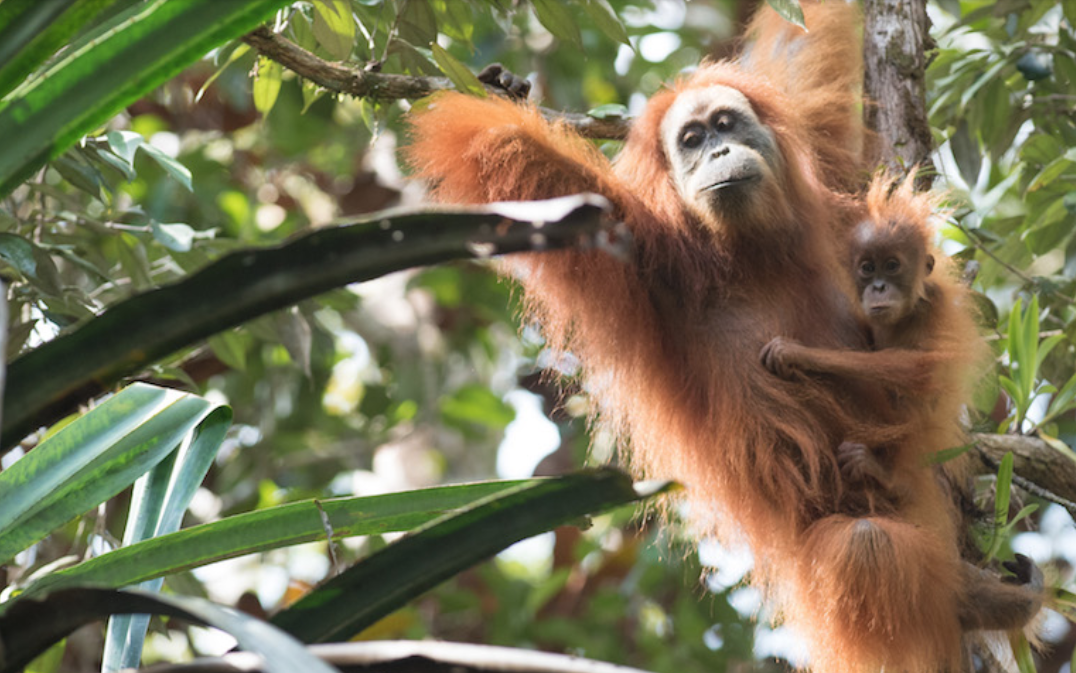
[272,469,667,643]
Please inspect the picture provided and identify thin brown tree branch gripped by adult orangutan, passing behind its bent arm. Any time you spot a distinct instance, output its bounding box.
[243,26,631,140]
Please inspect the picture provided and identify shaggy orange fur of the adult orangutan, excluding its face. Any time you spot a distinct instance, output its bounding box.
[406,2,989,672]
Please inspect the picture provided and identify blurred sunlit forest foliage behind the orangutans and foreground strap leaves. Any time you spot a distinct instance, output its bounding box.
[0,0,1076,673]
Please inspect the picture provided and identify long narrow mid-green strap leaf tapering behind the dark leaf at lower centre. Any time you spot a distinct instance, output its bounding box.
[27,481,538,594]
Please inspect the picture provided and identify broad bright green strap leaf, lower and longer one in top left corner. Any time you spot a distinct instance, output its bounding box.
[0,0,289,196]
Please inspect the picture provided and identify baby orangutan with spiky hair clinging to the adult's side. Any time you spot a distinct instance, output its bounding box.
[761,174,946,515]
